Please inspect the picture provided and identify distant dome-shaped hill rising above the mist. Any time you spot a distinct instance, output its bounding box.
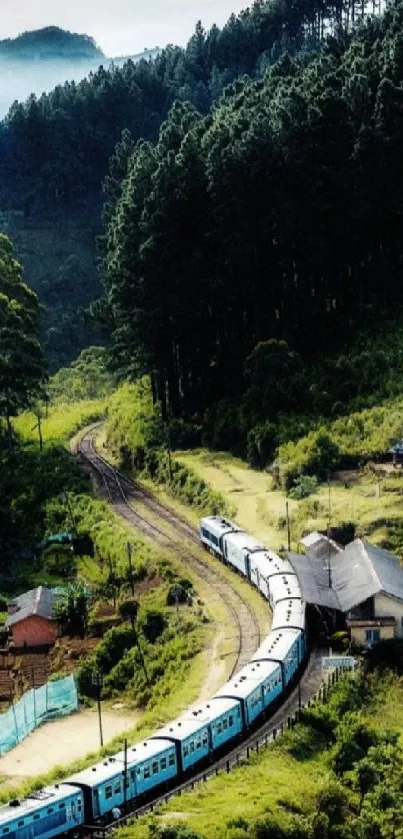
[0,26,104,61]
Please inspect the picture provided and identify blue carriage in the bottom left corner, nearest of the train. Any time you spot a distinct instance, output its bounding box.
[0,784,84,839]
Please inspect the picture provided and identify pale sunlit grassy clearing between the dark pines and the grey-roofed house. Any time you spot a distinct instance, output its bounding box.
[175,449,403,550]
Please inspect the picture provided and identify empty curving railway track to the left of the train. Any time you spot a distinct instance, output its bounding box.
[78,425,261,678]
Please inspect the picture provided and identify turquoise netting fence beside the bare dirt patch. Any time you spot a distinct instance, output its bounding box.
[0,676,78,755]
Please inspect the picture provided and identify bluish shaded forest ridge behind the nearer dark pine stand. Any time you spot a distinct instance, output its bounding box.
[0,0,388,369]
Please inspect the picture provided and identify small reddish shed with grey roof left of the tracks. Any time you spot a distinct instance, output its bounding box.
[6,586,59,648]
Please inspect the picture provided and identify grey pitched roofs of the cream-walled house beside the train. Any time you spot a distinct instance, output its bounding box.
[289,536,403,612]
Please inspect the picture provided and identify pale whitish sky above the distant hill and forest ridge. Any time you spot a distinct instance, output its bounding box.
[0,0,250,57]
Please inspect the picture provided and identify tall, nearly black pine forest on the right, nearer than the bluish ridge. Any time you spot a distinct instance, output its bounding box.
[103,3,403,462]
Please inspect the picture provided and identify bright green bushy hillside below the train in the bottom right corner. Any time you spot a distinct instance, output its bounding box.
[118,675,403,839]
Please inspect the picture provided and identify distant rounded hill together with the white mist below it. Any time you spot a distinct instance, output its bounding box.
[0,26,158,117]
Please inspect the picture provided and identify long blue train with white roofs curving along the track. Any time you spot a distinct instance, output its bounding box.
[0,516,307,839]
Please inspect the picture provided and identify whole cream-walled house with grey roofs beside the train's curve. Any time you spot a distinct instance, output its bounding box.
[289,534,403,646]
